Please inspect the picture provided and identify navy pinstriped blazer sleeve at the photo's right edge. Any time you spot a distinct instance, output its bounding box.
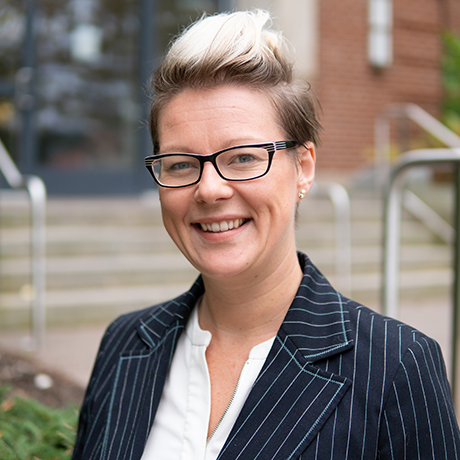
[378,336,460,460]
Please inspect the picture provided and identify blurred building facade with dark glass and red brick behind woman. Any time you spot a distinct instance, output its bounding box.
[0,0,460,194]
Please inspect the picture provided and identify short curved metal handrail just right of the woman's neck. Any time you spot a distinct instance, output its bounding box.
[310,182,352,297]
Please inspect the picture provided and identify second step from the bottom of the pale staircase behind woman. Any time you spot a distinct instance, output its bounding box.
[0,245,451,292]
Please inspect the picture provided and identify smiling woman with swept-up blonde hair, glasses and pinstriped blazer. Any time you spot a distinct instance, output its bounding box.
[73,11,460,460]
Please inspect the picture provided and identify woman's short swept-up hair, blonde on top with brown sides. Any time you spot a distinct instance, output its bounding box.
[150,9,321,152]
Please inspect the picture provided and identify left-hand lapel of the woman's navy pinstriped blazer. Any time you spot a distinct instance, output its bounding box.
[102,278,203,460]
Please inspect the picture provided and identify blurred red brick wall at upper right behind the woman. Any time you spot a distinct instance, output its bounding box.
[313,0,446,171]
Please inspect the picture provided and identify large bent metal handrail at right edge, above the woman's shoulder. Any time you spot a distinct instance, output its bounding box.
[382,148,460,391]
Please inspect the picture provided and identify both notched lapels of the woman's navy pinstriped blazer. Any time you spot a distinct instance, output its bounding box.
[102,254,353,460]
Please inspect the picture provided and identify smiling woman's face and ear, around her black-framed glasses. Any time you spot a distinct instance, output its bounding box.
[158,86,314,280]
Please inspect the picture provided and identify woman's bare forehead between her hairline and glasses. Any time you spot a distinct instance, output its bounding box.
[158,86,284,153]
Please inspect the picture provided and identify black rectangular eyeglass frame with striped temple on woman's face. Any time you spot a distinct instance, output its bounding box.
[144,141,299,188]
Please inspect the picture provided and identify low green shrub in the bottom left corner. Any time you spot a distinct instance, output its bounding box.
[0,387,78,460]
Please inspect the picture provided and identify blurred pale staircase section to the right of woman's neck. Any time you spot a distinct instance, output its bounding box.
[297,186,452,311]
